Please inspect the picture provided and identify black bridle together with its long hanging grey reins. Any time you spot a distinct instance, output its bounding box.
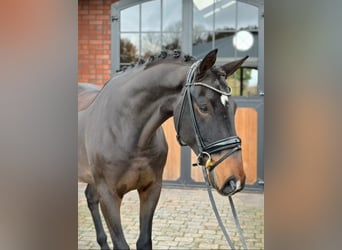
[176,60,247,249]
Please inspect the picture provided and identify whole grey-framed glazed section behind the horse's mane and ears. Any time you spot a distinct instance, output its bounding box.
[112,0,263,96]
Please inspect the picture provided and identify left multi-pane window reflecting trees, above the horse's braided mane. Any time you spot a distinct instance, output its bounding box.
[120,0,182,68]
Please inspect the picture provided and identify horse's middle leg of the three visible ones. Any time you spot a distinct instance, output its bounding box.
[97,185,129,249]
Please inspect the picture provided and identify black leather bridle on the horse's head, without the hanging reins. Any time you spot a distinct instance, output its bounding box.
[176,60,241,173]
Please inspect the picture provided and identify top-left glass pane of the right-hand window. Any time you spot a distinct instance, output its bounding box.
[193,0,214,32]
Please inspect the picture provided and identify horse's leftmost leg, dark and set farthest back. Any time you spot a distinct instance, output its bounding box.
[85,184,109,249]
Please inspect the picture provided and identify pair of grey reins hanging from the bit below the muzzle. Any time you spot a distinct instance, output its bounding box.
[202,166,247,250]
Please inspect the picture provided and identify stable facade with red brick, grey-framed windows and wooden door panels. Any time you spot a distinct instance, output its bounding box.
[78,0,264,190]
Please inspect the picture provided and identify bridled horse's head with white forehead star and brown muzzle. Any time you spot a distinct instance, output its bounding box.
[174,49,247,195]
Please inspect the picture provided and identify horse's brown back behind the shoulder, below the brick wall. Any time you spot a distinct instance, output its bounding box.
[78,83,101,111]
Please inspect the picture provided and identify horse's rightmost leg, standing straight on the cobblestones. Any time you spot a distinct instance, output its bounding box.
[137,182,161,249]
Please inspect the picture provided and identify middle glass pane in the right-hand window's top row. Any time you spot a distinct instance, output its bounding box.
[215,0,236,32]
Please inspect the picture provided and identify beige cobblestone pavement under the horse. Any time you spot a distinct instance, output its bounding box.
[78,184,264,249]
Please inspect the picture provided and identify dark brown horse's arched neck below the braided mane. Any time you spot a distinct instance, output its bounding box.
[95,64,187,148]
